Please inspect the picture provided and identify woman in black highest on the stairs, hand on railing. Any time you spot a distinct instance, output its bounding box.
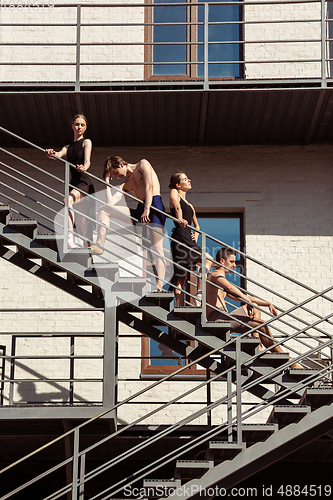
[46,114,95,248]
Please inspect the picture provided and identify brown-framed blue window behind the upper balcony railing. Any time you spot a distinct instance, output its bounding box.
[145,0,242,79]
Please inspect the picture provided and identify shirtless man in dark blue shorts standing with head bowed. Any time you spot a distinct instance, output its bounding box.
[91,156,165,291]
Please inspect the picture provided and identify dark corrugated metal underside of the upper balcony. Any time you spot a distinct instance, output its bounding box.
[0,88,333,146]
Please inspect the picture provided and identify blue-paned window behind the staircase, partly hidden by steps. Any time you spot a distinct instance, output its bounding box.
[141,212,245,375]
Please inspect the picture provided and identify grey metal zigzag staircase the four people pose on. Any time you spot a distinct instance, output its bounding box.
[0,128,333,500]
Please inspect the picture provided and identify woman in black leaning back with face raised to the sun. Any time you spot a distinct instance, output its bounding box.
[169,172,212,307]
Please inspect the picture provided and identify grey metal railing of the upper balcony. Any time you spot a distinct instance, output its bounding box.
[0,0,333,91]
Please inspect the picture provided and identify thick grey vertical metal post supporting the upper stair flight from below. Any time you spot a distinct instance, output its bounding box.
[103,292,118,407]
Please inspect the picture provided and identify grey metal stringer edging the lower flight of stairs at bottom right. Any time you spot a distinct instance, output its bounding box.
[167,403,333,500]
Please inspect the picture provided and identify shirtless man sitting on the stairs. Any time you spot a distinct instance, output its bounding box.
[206,248,302,368]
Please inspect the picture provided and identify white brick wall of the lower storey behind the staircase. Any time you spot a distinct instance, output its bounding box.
[0,145,333,423]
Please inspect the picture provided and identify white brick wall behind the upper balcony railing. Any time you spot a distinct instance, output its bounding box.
[0,0,321,82]
